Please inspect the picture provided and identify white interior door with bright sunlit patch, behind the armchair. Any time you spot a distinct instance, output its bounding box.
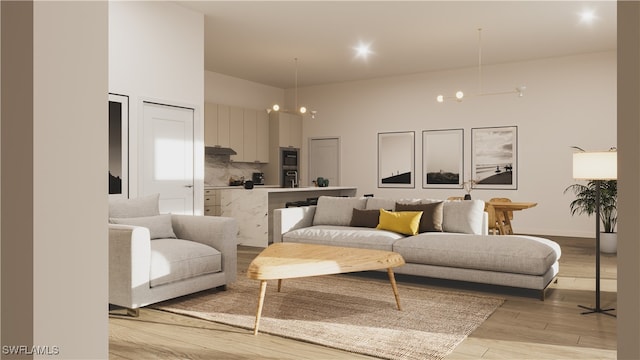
[140,102,194,215]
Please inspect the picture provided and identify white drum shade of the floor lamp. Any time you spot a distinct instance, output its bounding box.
[573,151,618,180]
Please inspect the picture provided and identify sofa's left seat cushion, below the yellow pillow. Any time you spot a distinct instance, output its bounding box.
[282,225,404,251]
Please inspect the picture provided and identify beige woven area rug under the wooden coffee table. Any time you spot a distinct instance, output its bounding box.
[153,274,504,360]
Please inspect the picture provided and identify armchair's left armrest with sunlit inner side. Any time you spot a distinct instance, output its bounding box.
[109,224,151,307]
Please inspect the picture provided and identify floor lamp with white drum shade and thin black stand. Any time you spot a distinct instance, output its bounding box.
[573,151,618,317]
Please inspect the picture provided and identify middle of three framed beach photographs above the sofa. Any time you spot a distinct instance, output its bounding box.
[422,129,464,189]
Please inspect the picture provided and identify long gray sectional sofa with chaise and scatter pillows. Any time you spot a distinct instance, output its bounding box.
[273,196,561,300]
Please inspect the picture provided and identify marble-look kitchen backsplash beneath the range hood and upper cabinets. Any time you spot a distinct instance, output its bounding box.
[204,155,269,186]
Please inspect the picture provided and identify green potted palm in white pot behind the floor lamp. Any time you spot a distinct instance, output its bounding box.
[564,180,618,253]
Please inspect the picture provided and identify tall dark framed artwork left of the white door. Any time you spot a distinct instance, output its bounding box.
[109,94,129,198]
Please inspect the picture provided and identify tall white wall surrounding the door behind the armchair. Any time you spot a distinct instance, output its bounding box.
[109,1,204,214]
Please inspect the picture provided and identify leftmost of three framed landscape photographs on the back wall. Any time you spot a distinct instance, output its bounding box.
[378,131,415,188]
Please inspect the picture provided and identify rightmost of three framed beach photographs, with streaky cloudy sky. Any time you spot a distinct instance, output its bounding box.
[471,126,518,190]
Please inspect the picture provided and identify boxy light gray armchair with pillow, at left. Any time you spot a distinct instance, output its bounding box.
[109,195,238,316]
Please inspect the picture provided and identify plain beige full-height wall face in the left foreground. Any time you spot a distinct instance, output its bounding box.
[34,1,109,359]
